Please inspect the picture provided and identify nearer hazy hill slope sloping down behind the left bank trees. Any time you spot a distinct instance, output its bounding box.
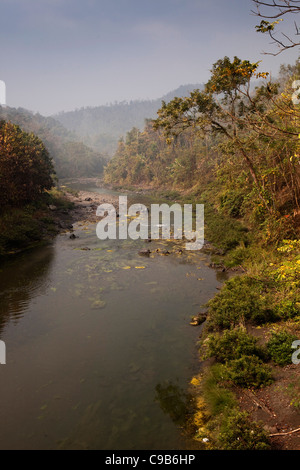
[0,106,107,178]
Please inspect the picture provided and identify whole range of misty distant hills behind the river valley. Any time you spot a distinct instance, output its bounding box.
[0,84,203,178]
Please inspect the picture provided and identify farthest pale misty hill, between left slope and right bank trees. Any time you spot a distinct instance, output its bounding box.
[53,84,203,156]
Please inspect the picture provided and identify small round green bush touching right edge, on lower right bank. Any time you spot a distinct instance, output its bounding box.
[267,330,298,366]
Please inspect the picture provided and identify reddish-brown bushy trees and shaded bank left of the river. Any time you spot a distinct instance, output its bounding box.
[0,121,74,256]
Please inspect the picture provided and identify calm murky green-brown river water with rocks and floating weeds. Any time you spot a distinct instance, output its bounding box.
[0,184,222,450]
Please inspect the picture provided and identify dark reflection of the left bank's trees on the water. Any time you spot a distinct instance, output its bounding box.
[0,246,54,333]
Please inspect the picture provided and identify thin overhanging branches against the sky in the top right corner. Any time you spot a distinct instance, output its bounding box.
[252,0,300,55]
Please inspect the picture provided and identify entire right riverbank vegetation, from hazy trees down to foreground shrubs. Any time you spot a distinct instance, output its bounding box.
[104,40,300,450]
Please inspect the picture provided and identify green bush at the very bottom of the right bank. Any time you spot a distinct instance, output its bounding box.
[218,410,271,450]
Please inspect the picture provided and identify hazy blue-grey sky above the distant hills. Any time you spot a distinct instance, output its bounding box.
[0,0,298,115]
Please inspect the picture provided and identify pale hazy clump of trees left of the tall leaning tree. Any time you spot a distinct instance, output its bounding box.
[104,122,214,191]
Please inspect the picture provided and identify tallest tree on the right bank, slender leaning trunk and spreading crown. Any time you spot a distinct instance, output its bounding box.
[155,57,267,206]
